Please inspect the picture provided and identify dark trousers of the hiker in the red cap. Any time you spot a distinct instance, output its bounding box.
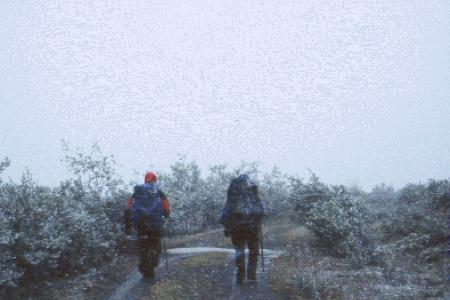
[138,229,161,275]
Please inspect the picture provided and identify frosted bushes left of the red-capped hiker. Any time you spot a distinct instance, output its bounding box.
[0,146,124,288]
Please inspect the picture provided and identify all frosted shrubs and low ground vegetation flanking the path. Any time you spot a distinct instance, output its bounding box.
[0,145,450,299]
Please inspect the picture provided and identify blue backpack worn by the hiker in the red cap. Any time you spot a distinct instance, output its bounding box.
[131,182,163,230]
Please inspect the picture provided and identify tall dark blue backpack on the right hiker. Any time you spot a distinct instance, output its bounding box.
[222,175,264,224]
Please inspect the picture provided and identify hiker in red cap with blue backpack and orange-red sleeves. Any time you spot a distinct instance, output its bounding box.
[124,172,170,279]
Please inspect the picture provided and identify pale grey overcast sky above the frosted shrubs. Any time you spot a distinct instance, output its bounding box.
[0,0,450,189]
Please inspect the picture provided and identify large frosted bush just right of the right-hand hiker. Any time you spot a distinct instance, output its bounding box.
[289,174,368,265]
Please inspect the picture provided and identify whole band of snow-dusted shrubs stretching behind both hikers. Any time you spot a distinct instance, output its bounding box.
[0,145,450,291]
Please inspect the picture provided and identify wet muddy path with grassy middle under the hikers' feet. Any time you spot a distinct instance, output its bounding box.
[108,247,281,300]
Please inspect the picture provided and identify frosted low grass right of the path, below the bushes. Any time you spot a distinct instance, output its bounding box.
[266,219,445,299]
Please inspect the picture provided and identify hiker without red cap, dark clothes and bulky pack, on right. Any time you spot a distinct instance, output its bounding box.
[220,174,264,284]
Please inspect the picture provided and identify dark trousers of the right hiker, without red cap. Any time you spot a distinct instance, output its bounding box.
[231,225,259,283]
